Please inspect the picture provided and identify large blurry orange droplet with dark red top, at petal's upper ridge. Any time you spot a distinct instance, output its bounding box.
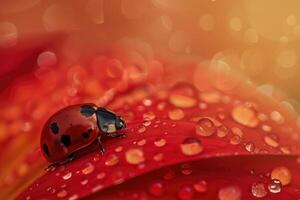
[169,83,197,108]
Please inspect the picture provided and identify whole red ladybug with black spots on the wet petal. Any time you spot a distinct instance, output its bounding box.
[40,103,126,165]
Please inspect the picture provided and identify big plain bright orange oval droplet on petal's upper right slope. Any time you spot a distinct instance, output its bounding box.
[231,105,259,128]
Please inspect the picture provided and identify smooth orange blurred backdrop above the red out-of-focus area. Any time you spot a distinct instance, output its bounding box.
[0,0,300,109]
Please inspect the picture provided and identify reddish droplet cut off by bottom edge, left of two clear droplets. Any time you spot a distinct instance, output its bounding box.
[218,185,242,200]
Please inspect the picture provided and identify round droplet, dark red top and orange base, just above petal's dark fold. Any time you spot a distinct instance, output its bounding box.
[180,137,203,156]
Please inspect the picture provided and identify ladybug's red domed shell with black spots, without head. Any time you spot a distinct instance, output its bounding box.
[40,104,99,162]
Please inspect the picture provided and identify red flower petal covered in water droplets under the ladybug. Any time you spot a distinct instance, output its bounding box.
[18,69,299,199]
